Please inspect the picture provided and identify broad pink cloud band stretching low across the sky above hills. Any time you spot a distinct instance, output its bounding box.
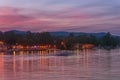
[0,7,119,31]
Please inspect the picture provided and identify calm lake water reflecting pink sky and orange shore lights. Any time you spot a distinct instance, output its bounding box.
[0,49,120,80]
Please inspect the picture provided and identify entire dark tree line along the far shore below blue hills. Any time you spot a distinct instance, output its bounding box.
[0,31,120,49]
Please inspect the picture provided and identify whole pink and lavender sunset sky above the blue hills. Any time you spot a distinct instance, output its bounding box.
[0,0,120,34]
